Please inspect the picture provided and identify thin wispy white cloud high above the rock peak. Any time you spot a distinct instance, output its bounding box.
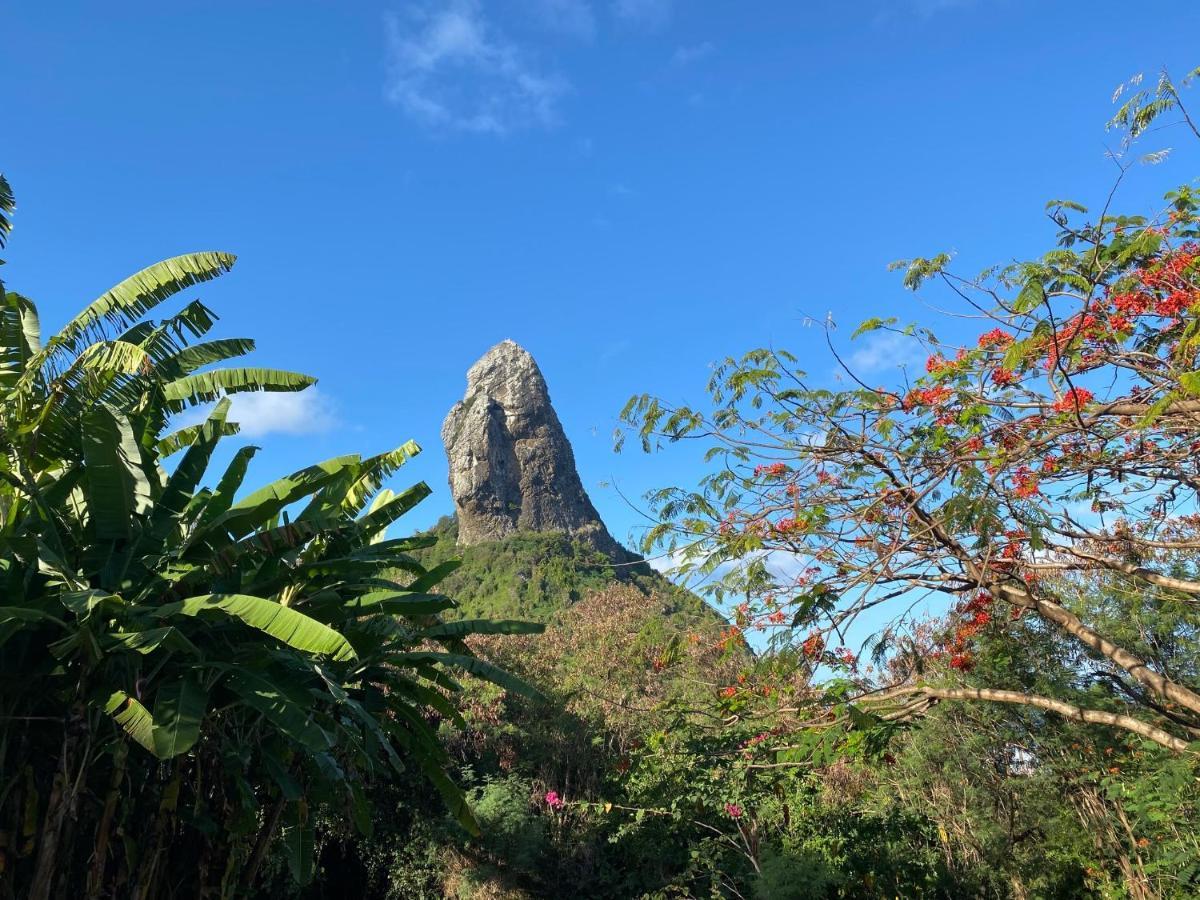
[384,0,569,134]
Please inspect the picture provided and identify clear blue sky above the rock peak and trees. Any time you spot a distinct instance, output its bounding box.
[0,0,1200,564]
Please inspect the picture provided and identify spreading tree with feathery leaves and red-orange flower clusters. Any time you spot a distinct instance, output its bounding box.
[623,65,1200,751]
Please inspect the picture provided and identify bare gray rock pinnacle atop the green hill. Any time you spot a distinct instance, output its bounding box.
[442,341,630,560]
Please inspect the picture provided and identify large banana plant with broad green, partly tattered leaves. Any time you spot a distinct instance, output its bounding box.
[0,176,540,900]
